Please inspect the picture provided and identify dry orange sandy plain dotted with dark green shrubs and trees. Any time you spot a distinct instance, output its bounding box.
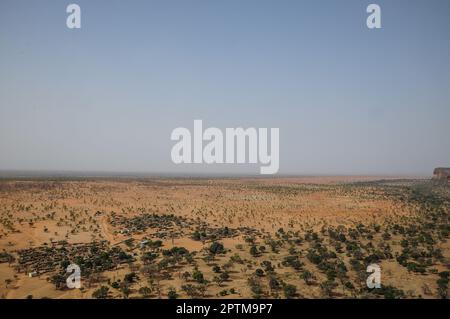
[0,177,450,298]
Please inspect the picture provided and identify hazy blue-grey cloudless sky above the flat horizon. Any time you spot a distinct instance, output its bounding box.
[0,0,450,175]
